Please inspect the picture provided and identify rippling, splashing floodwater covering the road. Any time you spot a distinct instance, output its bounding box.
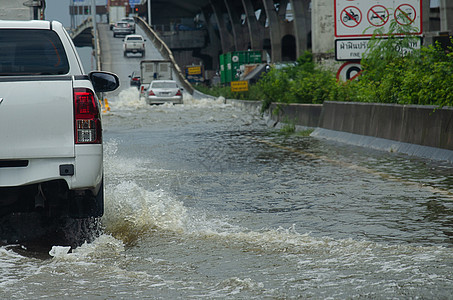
[0,24,453,299]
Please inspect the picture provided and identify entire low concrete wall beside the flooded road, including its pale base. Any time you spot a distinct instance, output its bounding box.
[226,100,453,163]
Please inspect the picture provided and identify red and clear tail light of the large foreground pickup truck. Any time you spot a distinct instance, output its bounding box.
[74,88,102,144]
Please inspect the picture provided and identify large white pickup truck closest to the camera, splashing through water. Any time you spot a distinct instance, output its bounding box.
[0,21,119,218]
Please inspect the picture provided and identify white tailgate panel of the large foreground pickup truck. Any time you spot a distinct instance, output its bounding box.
[0,76,74,159]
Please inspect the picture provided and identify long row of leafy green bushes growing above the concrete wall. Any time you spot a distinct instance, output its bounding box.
[192,24,453,111]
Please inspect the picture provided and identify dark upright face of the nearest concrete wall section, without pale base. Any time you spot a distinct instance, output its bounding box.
[318,102,453,150]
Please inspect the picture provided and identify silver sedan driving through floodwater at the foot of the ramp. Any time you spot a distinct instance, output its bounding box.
[146,80,182,104]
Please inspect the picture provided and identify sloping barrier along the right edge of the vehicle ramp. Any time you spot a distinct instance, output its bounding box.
[134,17,194,95]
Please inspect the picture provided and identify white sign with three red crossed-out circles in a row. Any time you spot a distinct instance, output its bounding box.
[334,0,426,38]
